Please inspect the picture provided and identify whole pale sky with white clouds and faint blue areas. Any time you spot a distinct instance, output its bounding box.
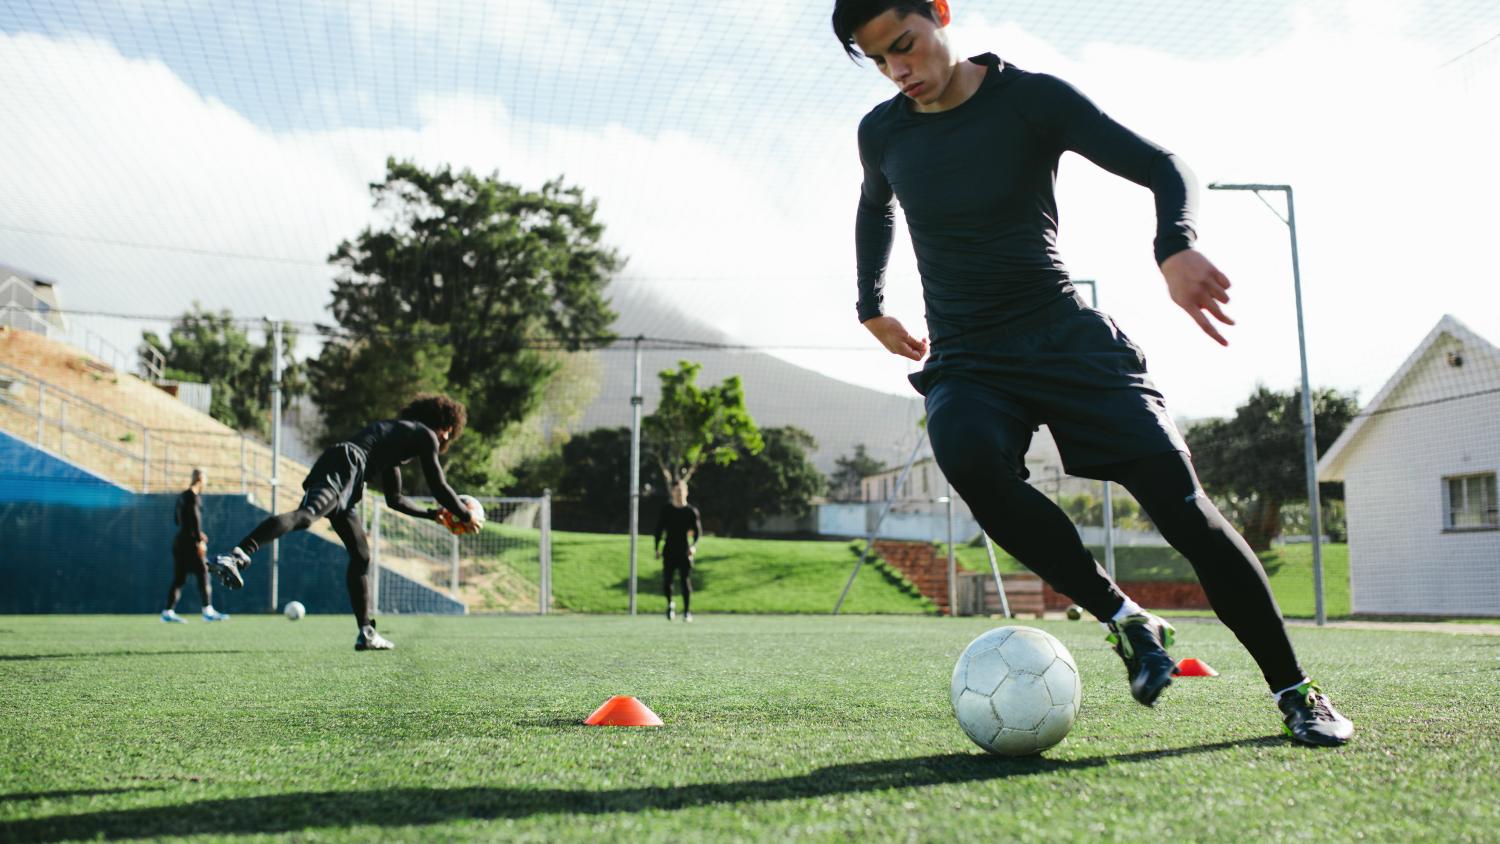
[0,0,1500,417]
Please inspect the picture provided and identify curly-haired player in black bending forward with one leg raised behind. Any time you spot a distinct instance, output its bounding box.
[209,396,471,651]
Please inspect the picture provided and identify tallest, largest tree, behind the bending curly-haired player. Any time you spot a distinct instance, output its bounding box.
[318,159,624,490]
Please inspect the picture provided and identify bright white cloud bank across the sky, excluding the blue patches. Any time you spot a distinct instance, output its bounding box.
[0,3,1500,415]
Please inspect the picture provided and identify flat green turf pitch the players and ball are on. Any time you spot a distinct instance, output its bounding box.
[0,616,1500,843]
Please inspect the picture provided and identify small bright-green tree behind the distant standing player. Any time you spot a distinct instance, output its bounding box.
[642,360,765,489]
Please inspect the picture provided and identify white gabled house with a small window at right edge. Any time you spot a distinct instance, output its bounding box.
[1317,316,1500,616]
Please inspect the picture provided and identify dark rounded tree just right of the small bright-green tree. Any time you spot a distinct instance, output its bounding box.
[693,426,828,537]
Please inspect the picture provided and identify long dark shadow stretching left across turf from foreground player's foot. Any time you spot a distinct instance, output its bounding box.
[0,736,1286,843]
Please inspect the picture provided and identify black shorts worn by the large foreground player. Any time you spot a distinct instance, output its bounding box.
[911,290,1188,478]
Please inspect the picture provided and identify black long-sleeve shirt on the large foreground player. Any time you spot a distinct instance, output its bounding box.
[855,52,1197,346]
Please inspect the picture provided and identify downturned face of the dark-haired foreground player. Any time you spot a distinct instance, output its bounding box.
[854,6,954,111]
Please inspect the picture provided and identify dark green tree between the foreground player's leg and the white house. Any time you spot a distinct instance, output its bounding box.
[1187,385,1359,552]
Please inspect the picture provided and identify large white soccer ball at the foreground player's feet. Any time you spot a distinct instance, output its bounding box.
[951,627,1083,756]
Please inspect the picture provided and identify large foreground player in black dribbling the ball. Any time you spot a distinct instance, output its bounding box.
[833,0,1353,745]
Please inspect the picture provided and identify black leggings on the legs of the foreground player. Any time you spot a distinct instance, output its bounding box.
[932,431,1305,690]
